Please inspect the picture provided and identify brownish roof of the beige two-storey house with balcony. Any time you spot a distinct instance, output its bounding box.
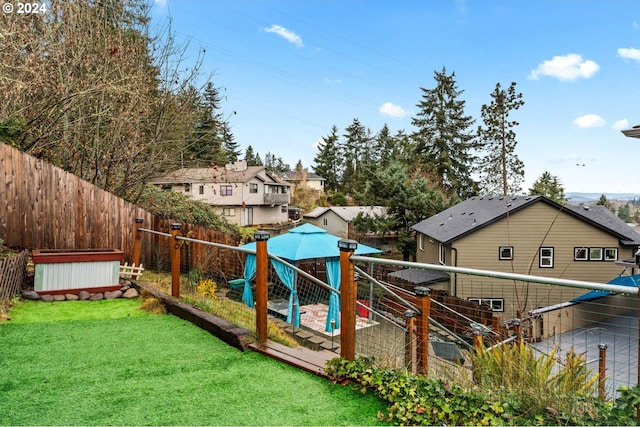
[149,166,289,186]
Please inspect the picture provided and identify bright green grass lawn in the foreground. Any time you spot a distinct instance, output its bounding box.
[0,299,385,425]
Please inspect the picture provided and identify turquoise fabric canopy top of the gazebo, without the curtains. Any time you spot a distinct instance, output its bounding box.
[241,224,382,262]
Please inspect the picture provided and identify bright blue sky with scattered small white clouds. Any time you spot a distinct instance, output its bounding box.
[153,0,640,193]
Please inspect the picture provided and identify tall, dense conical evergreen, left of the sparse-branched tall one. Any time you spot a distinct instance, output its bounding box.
[411,67,478,198]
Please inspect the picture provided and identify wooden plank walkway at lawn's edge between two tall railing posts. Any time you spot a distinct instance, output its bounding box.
[249,340,338,377]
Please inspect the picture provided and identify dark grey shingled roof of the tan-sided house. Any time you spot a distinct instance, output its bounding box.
[411,196,640,245]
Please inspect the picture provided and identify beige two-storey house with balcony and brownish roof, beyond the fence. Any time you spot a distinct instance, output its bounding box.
[150,162,290,226]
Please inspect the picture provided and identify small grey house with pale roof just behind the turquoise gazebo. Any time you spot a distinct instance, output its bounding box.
[303,206,387,239]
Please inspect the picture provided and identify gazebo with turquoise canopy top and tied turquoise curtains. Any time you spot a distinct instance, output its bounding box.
[242,224,382,332]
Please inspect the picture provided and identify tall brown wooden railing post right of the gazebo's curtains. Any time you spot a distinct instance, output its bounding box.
[338,239,358,360]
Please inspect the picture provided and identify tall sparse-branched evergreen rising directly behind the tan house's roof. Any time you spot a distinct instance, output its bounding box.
[478,82,524,196]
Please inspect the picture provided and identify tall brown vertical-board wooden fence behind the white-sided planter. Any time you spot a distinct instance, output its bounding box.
[0,143,240,274]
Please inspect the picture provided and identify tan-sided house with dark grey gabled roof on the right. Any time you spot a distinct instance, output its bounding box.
[412,196,640,318]
